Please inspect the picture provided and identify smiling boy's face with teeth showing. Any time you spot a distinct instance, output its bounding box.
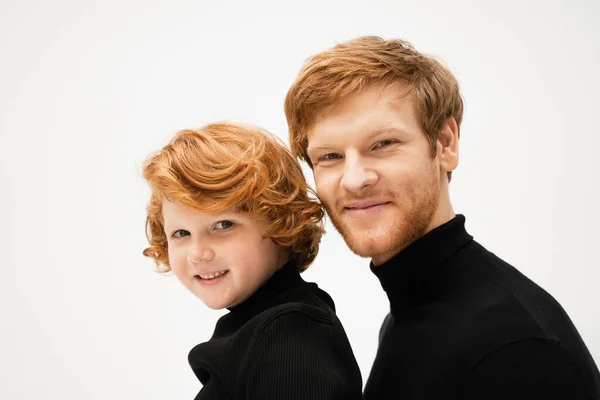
[162,200,285,310]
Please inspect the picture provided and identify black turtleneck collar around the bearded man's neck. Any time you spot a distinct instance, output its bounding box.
[371,214,473,312]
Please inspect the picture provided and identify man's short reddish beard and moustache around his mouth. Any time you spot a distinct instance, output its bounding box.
[323,171,440,261]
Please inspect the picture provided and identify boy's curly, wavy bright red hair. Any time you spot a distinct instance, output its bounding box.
[143,123,324,272]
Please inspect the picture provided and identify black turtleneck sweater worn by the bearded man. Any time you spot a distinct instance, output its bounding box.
[364,215,600,400]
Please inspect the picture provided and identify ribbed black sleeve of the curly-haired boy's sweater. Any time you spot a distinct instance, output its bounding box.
[242,303,362,399]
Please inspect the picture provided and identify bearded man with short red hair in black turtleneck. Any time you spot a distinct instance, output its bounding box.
[285,37,600,400]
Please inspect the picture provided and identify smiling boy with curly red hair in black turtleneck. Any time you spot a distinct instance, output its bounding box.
[143,124,362,400]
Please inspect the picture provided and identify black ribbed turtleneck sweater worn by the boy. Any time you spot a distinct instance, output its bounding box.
[188,262,362,400]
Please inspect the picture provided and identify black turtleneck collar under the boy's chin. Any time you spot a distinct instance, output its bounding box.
[213,260,307,336]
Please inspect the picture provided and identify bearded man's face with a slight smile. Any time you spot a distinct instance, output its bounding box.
[308,84,445,265]
